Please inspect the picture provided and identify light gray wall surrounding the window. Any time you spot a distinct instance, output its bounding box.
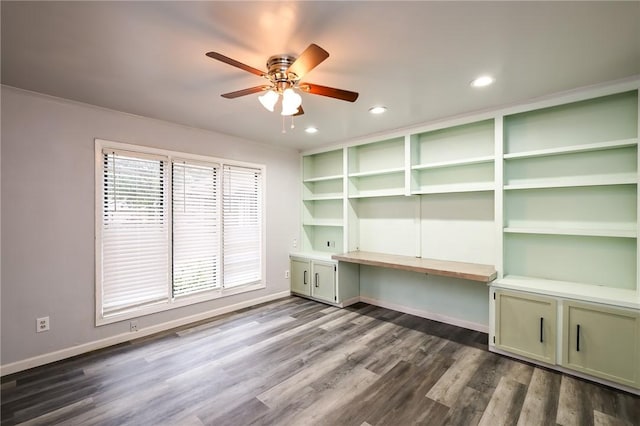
[0,86,300,365]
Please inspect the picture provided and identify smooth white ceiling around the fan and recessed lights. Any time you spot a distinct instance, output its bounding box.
[0,1,640,150]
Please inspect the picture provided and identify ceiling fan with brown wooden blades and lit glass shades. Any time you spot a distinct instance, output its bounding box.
[207,44,358,115]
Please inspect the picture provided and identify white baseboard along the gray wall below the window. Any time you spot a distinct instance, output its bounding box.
[0,290,291,376]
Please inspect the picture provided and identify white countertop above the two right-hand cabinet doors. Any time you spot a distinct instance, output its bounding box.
[491,275,640,309]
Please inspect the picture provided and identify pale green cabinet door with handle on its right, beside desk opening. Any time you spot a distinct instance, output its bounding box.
[495,290,556,364]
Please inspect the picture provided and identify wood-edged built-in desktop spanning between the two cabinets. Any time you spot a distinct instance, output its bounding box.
[331,251,497,283]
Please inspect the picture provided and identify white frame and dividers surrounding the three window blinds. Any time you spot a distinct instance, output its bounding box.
[94,138,267,326]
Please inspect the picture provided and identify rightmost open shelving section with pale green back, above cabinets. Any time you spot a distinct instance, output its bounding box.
[498,90,638,303]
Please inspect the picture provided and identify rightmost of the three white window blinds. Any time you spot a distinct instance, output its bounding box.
[222,165,262,288]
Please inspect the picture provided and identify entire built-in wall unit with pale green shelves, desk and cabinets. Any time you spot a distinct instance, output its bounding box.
[292,80,640,393]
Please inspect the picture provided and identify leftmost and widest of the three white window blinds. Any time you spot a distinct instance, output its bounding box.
[101,150,169,316]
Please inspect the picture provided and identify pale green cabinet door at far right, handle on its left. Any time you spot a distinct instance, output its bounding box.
[562,302,640,387]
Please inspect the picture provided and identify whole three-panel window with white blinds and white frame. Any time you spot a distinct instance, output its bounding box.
[96,140,264,324]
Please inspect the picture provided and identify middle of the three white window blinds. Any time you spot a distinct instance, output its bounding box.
[172,161,220,297]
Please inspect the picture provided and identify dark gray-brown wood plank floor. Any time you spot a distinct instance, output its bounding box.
[2,297,640,426]
